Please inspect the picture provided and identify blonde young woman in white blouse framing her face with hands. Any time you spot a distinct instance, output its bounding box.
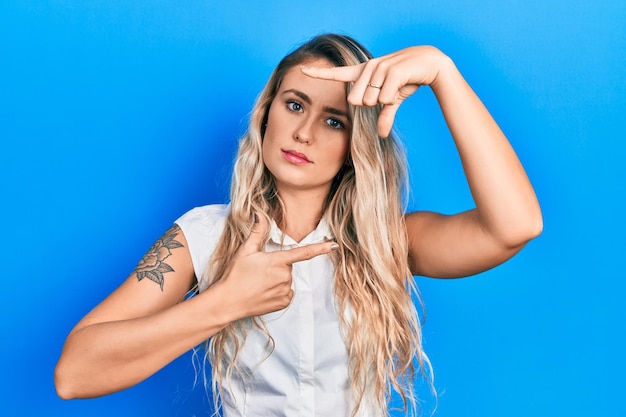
[55,34,542,417]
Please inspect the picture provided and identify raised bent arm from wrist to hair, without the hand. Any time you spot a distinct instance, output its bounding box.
[406,52,543,277]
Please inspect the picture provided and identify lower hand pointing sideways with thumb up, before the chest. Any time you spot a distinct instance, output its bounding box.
[211,215,338,321]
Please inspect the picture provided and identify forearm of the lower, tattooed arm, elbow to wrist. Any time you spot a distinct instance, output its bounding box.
[55,293,229,399]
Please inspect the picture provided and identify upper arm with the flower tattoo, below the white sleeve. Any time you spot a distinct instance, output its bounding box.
[72,224,196,333]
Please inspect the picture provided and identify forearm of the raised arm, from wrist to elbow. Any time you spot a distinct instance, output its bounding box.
[431,59,542,247]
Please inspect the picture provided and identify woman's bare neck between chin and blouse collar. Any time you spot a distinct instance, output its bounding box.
[279,185,327,242]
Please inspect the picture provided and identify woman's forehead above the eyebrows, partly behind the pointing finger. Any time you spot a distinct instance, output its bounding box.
[278,58,348,111]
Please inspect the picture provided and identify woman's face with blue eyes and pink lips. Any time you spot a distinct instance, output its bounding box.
[263,59,351,196]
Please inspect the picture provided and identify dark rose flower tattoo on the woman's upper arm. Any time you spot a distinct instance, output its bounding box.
[134,224,183,291]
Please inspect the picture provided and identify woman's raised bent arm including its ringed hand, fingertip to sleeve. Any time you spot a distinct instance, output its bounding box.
[302,46,543,277]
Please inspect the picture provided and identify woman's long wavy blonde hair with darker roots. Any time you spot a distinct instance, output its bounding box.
[199,34,430,416]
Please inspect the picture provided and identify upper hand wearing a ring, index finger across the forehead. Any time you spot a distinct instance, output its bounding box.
[301,46,452,137]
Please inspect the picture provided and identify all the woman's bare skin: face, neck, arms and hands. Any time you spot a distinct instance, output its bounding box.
[55,46,542,398]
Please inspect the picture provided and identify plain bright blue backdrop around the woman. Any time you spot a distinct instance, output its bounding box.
[0,0,626,417]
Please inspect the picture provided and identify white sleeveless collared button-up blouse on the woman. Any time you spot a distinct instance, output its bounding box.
[176,205,377,417]
